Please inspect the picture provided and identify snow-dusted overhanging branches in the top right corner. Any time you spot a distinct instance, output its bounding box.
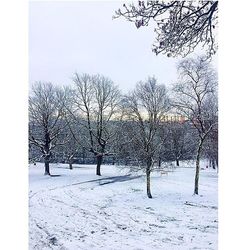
[114,0,218,57]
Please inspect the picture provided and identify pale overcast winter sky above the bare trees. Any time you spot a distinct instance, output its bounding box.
[29,1,182,92]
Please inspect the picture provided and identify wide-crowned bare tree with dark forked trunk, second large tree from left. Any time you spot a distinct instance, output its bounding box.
[70,73,120,175]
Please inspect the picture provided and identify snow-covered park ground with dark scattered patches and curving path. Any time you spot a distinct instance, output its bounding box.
[29,163,218,250]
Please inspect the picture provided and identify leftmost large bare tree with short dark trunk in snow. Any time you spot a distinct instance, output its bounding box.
[29,82,66,175]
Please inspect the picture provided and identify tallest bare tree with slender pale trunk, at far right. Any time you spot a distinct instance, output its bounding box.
[173,57,218,194]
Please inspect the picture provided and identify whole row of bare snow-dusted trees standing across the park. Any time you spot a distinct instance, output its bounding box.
[29,57,218,198]
